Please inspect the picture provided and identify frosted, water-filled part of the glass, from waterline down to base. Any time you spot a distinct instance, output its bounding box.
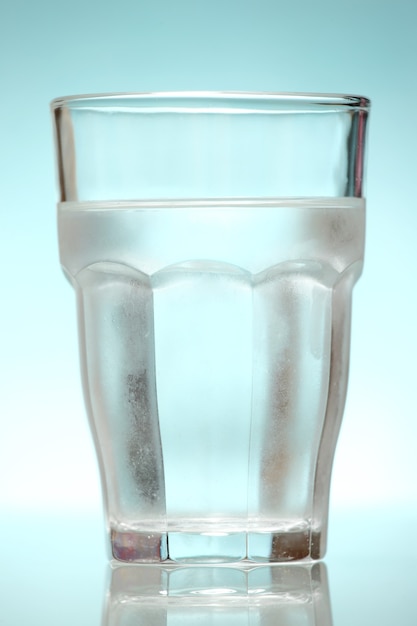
[59,198,365,562]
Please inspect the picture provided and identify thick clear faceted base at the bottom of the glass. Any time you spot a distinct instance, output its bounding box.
[111,529,323,564]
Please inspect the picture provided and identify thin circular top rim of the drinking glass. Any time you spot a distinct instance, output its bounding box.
[50,91,371,113]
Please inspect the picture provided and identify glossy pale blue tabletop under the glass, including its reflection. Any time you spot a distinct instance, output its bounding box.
[0,511,417,626]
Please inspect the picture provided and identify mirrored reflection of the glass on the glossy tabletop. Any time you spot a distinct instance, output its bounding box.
[103,563,332,626]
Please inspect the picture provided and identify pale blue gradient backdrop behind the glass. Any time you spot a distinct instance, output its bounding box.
[0,0,417,626]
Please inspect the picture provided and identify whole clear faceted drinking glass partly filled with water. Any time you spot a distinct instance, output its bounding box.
[52,94,369,563]
